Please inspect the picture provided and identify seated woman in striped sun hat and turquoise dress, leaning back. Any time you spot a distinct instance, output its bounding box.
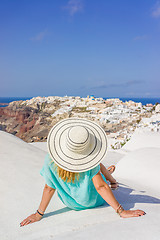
[20,118,145,226]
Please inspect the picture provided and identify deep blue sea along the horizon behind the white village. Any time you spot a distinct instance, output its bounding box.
[0,97,160,107]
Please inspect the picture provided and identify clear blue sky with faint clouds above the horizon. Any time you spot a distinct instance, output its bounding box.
[0,0,160,97]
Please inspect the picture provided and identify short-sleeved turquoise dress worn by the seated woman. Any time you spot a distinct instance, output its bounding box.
[40,153,107,210]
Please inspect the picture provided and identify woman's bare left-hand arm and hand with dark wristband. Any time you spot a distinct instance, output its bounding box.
[20,184,55,227]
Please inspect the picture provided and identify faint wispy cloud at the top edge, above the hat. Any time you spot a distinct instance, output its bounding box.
[63,0,83,16]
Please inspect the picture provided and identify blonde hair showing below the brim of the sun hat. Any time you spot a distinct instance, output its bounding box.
[52,160,80,183]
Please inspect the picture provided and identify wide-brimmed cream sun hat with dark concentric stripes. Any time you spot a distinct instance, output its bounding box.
[47,118,107,172]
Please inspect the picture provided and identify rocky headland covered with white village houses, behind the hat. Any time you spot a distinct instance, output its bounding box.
[0,96,160,149]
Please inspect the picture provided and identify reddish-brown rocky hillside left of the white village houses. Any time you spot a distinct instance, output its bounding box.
[0,101,68,142]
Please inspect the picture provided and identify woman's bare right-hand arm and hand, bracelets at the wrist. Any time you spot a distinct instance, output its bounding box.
[92,172,145,218]
